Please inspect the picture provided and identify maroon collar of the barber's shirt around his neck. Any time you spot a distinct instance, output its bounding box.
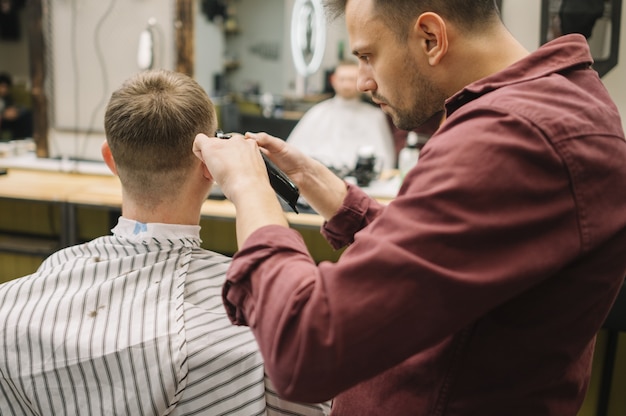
[446,34,593,115]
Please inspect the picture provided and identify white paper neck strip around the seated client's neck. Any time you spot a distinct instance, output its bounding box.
[111,217,202,246]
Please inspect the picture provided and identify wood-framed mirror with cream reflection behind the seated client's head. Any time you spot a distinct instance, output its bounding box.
[27,0,190,160]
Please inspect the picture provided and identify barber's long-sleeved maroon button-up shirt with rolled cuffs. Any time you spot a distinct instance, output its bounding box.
[224,35,626,416]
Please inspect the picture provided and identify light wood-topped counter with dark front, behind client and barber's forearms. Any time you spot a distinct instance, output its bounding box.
[0,168,341,281]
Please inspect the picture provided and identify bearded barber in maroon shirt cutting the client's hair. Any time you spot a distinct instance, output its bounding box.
[194,0,626,416]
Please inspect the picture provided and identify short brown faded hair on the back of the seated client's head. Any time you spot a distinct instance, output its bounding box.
[104,69,217,202]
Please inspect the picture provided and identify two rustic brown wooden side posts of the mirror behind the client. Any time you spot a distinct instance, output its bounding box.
[26,0,195,158]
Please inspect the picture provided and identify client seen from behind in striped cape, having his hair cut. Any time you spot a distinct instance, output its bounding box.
[0,70,330,416]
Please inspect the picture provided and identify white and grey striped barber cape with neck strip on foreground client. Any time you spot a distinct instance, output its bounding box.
[0,218,330,416]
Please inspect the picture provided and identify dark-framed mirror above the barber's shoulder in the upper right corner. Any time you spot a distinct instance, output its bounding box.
[541,0,622,76]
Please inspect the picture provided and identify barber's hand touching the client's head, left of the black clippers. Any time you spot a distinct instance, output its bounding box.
[193,134,273,202]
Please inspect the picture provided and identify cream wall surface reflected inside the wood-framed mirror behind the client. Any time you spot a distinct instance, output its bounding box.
[47,0,175,160]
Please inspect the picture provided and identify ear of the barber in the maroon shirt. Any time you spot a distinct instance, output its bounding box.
[413,12,448,66]
